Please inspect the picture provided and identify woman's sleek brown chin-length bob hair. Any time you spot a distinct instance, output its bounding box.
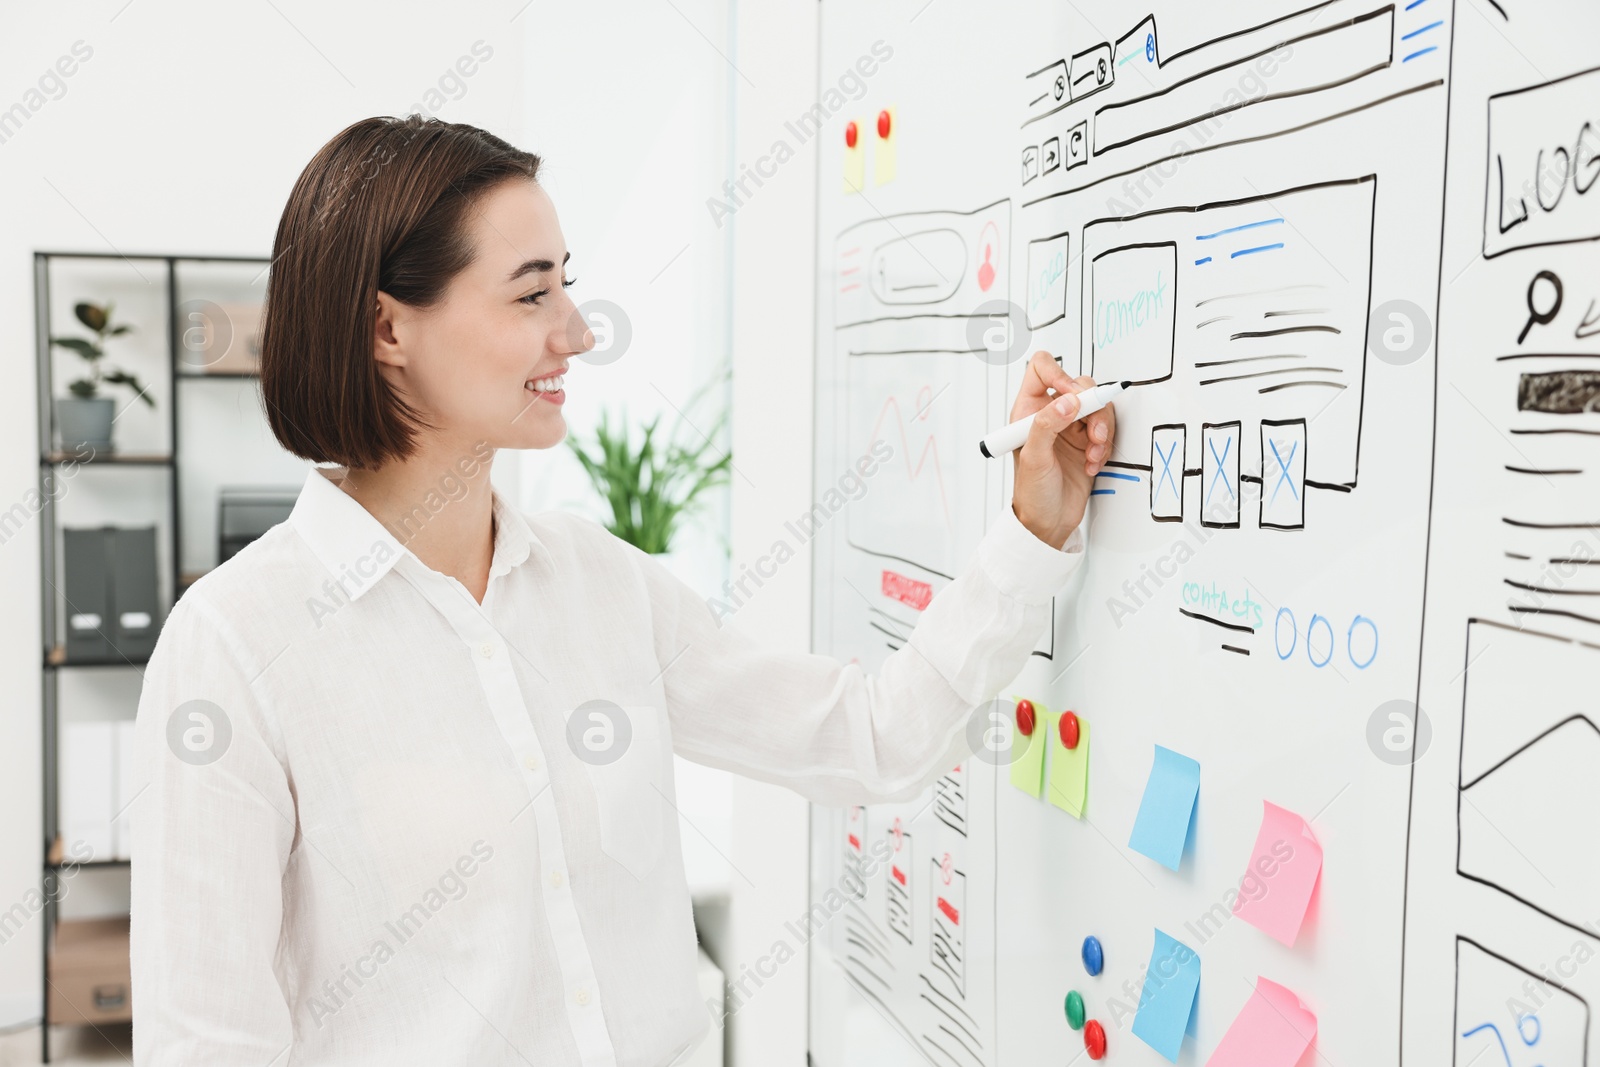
[261,114,539,469]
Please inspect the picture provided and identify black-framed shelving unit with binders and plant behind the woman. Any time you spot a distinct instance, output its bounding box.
[34,251,306,1062]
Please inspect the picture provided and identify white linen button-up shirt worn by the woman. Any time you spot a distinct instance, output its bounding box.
[130,470,1083,1067]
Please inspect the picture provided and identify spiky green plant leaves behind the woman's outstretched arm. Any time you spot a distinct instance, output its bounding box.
[566,385,733,555]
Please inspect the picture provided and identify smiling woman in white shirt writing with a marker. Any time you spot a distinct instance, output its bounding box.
[131,115,1114,1067]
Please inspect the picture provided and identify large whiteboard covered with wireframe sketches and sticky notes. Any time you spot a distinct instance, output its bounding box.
[806,0,1600,1067]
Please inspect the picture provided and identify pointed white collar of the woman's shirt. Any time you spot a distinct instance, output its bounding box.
[290,467,547,600]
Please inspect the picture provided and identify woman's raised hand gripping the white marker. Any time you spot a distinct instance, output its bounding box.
[1011,352,1117,549]
